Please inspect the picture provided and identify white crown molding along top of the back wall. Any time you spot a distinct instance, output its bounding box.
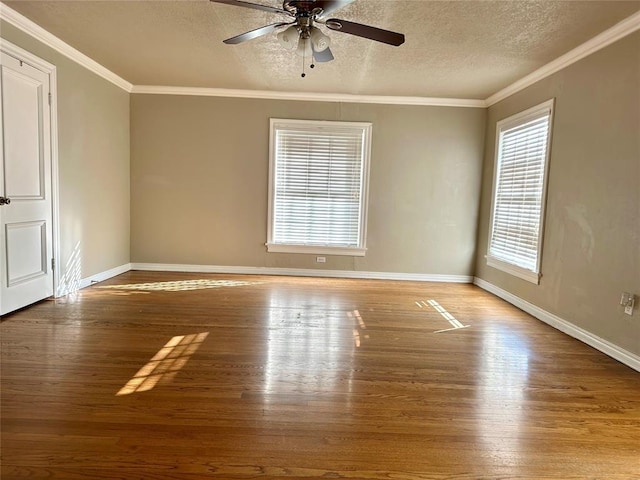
[131,85,487,108]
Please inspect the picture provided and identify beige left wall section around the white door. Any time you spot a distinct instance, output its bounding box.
[0,22,130,282]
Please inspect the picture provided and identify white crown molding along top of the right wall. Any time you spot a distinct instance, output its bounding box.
[485,12,640,107]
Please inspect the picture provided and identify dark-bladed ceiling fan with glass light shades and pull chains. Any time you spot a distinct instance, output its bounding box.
[211,0,404,70]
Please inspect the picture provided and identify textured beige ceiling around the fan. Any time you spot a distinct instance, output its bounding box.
[3,0,640,99]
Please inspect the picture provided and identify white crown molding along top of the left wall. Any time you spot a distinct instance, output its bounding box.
[0,2,133,93]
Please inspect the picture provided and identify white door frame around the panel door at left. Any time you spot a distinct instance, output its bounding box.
[0,38,60,297]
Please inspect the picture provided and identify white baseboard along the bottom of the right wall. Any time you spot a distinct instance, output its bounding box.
[473,277,640,372]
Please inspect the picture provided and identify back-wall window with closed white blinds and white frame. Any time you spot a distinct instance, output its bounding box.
[267,119,371,256]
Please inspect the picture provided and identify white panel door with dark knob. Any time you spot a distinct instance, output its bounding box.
[0,53,53,315]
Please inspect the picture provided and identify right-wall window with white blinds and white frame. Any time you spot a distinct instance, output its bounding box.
[487,100,553,283]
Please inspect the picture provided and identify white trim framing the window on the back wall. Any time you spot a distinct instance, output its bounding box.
[265,118,373,257]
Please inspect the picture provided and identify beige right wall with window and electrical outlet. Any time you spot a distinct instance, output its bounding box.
[476,29,640,354]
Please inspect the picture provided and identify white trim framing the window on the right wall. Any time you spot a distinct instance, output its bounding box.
[485,98,555,285]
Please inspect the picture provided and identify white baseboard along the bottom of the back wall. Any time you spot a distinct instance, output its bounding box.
[131,263,473,283]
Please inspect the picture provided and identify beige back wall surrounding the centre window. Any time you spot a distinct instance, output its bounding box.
[131,94,486,275]
